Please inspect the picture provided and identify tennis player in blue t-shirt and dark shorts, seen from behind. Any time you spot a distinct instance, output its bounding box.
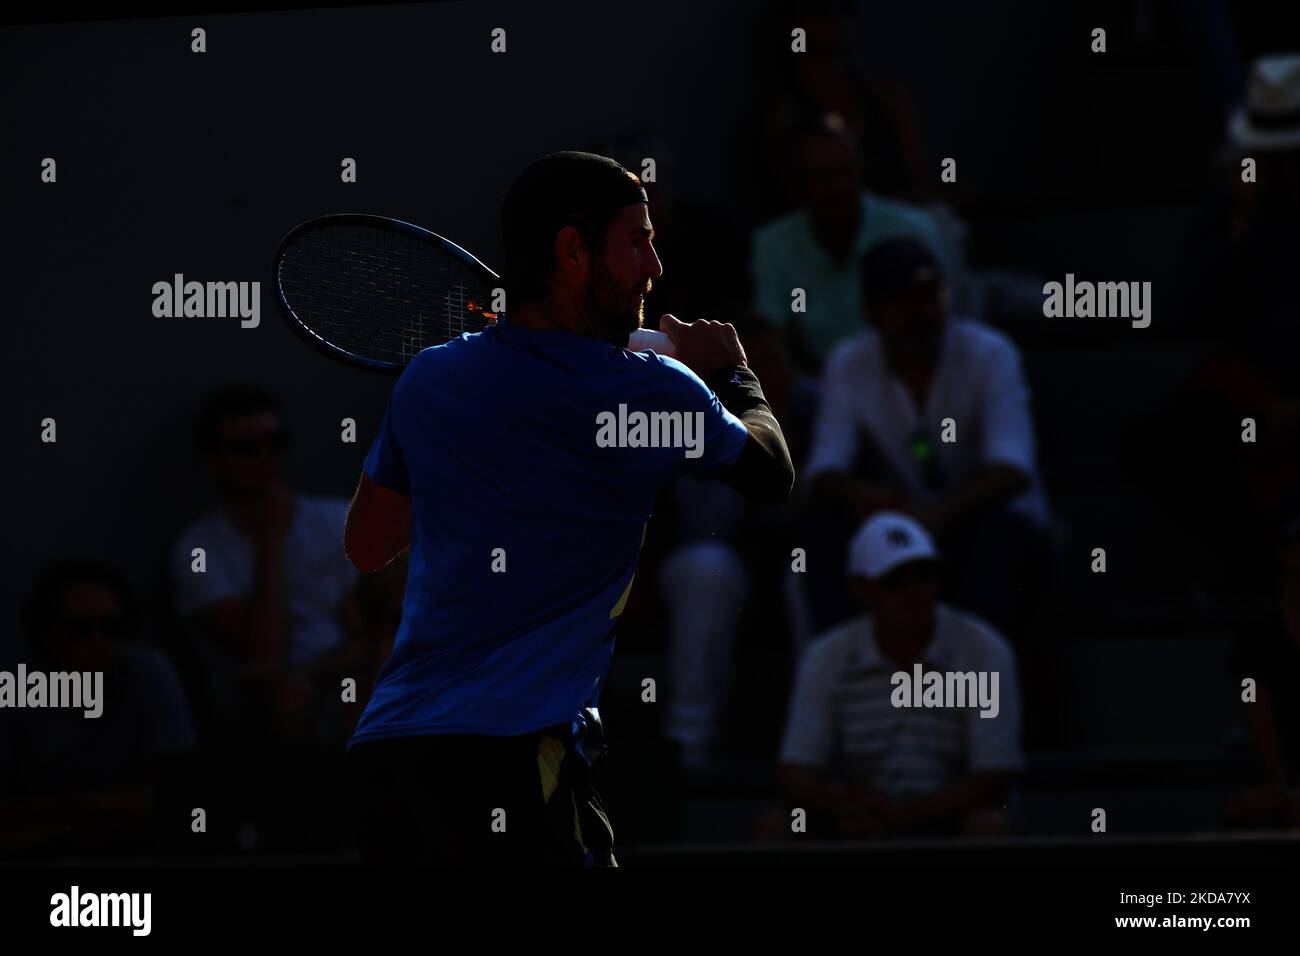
[346,152,794,866]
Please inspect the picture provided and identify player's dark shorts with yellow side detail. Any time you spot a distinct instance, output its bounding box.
[348,727,618,866]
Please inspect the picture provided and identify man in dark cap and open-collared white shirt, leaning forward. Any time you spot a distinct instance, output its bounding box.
[802,238,1056,641]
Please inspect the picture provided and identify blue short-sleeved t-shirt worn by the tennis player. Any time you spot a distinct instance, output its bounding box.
[351,323,749,744]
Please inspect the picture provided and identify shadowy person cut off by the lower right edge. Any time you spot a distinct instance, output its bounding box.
[1225,502,1300,827]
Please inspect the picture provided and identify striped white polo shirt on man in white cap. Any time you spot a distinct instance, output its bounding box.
[781,604,1024,799]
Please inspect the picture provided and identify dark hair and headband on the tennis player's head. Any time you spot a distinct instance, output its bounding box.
[501,152,645,306]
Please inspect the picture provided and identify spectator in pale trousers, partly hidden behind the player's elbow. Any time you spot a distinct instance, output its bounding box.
[659,313,816,769]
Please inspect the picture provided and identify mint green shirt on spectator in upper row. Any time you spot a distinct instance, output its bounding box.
[750,191,958,360]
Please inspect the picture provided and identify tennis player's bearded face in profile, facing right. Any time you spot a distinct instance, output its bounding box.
[584,203,663,345]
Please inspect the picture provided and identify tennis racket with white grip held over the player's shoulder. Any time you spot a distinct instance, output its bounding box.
[272,213,675,375]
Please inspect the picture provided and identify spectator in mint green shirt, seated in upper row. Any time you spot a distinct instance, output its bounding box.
[750,114,962,373]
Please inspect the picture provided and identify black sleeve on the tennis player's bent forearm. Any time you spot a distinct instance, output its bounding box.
[705,364,794,505]
